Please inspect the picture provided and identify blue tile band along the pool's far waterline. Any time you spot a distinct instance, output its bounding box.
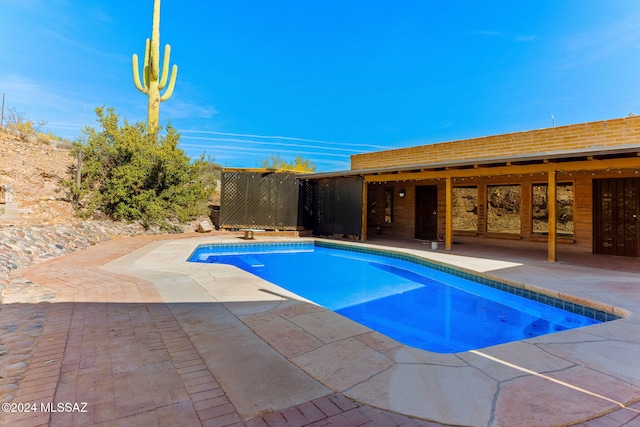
[187,239,624,322]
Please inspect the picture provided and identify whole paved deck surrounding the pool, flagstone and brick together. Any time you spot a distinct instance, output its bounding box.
[4,236,640,426]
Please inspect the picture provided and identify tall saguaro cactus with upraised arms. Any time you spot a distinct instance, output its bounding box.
[131,0,178,133]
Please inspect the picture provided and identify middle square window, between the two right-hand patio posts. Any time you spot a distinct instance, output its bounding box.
[487,185,521,234]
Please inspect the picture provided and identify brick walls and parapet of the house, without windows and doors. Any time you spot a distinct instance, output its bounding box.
[358,116,640,252]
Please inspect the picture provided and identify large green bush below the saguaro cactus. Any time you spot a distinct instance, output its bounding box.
[61,108,215,226]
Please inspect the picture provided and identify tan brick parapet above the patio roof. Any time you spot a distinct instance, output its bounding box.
[351,116,640,170]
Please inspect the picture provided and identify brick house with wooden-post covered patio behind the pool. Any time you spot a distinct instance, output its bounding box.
[299,116,640,262]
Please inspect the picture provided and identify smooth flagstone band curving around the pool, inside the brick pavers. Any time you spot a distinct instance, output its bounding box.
[126,238,640,425]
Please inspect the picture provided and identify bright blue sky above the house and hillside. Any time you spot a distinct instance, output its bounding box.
[0,0,640,171]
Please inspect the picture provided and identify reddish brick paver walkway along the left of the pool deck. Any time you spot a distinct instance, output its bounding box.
[0,236,439,427]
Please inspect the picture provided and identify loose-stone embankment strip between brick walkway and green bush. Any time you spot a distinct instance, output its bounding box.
[0,221,174,303]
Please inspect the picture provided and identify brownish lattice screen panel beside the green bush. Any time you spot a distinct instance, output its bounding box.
[220,170,303,230]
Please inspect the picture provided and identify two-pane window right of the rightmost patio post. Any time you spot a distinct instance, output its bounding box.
[531,182,573,236]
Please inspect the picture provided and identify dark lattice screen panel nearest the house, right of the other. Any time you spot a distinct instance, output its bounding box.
[304,177,364,239]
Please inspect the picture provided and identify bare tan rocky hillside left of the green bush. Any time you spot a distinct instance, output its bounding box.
[0,129,76,226]
